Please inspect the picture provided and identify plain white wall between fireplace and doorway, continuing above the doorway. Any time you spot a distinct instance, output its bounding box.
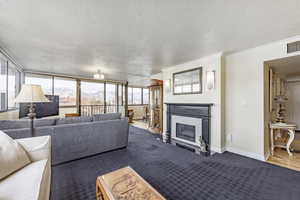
[225,36,300,160]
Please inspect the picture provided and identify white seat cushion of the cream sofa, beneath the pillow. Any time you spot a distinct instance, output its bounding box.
[0,159,50,200]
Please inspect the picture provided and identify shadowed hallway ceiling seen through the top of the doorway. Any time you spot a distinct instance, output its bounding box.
[267,56,300,78]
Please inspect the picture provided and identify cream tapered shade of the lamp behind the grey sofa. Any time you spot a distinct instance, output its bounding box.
[15,84,50,103]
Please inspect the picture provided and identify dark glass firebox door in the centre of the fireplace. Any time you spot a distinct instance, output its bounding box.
[176,123,196,142]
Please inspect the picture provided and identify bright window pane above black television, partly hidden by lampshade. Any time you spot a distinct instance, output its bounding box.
[25,73,52,95]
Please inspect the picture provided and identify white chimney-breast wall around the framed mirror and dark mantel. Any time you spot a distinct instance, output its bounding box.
[162,53,225,152]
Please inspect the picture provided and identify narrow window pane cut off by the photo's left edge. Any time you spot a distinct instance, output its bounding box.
[0,57,7,111]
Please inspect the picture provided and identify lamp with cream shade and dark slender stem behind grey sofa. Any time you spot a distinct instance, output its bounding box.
[15,84,50,136]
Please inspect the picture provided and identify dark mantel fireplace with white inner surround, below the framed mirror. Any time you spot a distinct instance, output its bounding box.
[164,103,213,155]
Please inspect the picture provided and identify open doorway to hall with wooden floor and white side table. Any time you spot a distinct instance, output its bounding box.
[264,56,300,171]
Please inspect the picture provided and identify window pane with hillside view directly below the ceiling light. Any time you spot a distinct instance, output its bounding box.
[81,81,104,105]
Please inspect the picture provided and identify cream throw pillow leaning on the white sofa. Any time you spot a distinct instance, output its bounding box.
[0,131,30,179]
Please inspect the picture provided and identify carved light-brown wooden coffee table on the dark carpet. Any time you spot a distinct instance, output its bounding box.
[96,167,165,200]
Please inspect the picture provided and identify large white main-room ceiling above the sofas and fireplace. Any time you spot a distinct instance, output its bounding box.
[0,0,300,85]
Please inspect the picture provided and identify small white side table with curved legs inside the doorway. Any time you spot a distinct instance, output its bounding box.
[270,123,297,156]
